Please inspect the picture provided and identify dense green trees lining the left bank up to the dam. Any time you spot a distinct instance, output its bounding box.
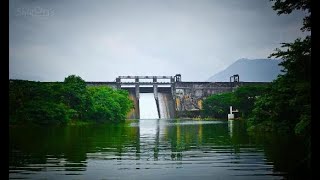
[9,75,133,124]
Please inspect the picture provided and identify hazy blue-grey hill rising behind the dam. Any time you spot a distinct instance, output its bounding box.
[208,59,282,82]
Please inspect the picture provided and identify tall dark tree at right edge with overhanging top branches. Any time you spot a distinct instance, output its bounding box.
[249,0,311,135]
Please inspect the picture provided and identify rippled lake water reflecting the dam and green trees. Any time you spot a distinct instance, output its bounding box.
[9,119,310,179]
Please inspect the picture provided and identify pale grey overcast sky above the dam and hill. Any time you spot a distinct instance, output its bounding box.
[9,0,305,81]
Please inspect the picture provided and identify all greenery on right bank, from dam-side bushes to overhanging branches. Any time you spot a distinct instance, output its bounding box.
[203,0,311,169]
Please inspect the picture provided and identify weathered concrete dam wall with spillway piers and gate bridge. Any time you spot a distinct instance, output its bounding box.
[87,74,268,119]
